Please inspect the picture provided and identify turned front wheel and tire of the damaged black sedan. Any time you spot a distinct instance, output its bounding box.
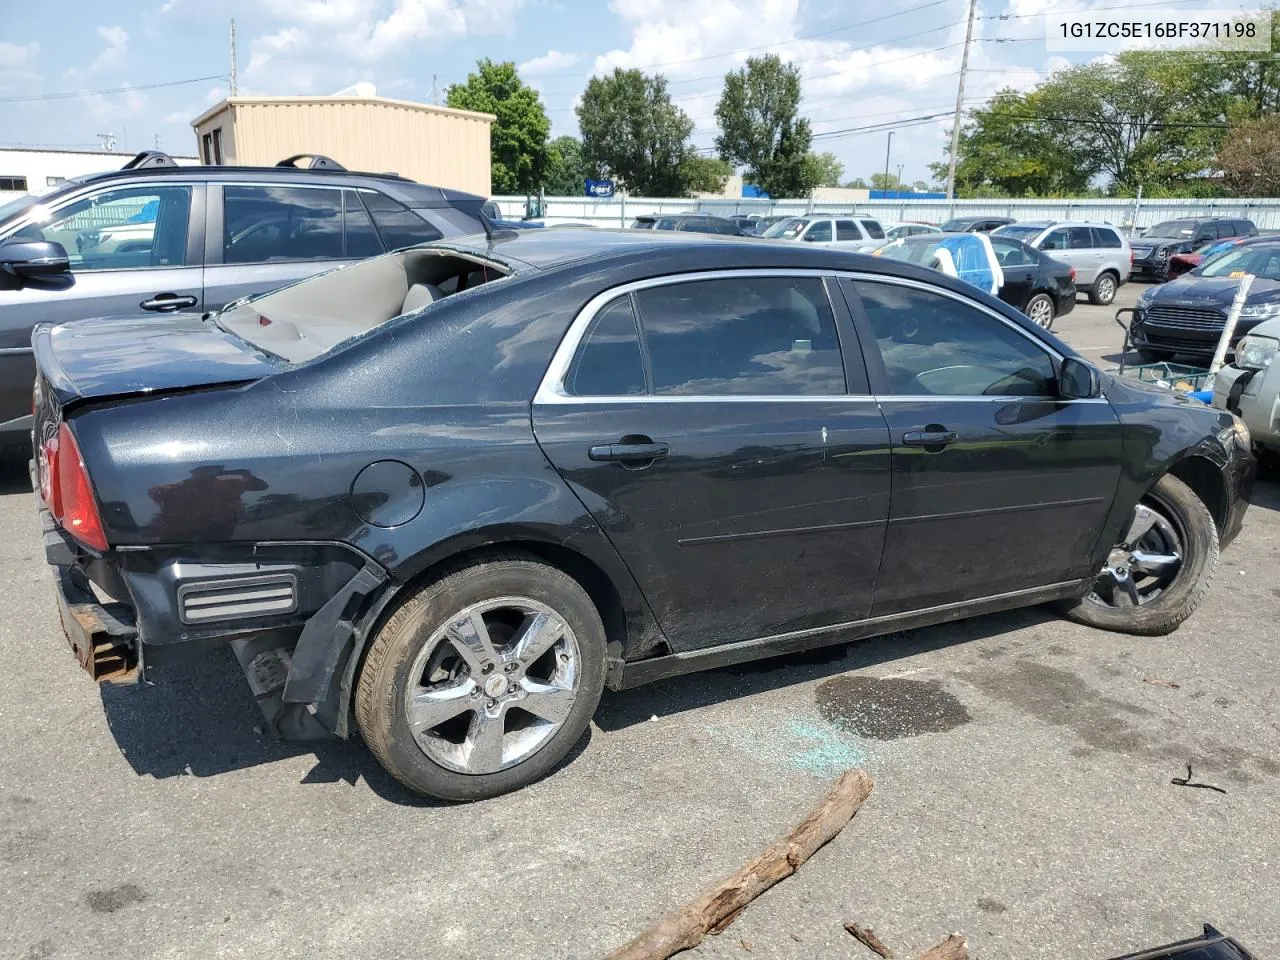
[1064,475,1219,636]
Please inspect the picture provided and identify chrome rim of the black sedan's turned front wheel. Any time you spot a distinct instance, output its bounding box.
[1088,503,1183,607]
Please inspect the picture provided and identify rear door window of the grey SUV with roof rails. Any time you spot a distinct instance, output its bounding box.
[223,183,342,264]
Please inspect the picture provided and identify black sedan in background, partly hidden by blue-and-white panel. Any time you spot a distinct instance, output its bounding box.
[876,233,1075,330]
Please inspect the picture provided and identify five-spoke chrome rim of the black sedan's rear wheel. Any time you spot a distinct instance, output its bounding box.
[404,596,581,774]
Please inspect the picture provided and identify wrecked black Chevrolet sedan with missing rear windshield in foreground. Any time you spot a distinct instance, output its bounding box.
[33,228,1253,799]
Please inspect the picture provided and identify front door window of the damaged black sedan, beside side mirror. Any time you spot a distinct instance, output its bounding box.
[851,280,1056,397]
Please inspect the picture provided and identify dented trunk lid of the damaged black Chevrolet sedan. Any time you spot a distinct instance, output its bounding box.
[31,314,284,403]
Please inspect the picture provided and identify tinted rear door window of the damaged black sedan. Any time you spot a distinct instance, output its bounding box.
[635,276,845,397]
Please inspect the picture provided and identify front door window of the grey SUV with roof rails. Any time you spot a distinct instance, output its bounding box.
[18,187,191,271]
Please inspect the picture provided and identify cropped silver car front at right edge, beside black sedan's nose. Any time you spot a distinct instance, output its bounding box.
[1213,317,1280,468]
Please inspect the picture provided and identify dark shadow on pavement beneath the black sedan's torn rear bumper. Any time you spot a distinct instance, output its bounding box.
[99,649,476,806]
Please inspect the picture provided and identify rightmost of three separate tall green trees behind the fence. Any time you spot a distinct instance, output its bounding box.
[716,54,818,197]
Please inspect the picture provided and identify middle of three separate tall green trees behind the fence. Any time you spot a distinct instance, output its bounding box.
[577,68,694,197]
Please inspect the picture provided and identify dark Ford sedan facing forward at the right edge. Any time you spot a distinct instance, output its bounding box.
[1130,237,1280,364]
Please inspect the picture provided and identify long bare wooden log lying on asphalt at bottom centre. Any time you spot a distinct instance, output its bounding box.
[608,771,874,960]
